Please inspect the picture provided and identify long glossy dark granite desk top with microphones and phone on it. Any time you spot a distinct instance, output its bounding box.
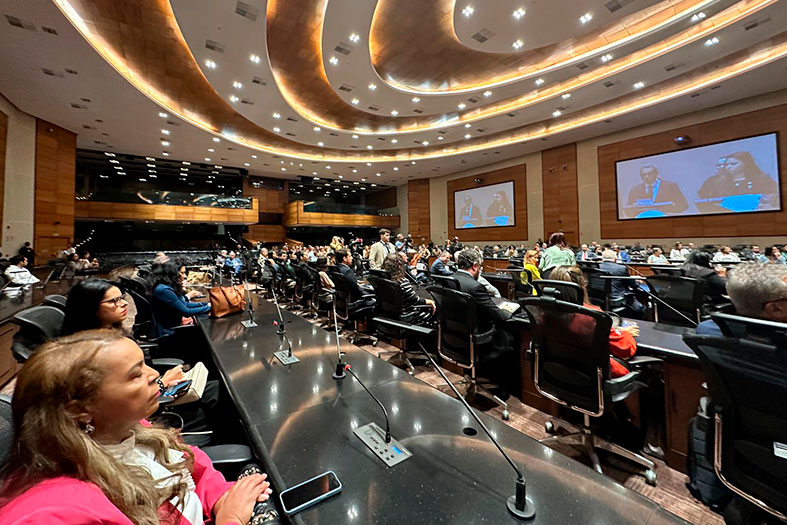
[203,298,681,524]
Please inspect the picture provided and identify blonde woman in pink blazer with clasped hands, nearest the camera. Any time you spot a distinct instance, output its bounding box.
[0,330,270,525]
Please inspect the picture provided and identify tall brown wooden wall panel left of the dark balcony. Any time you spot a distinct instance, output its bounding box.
[33,119,76,261]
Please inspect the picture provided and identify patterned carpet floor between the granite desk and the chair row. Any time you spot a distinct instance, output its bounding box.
[294,302,724,525]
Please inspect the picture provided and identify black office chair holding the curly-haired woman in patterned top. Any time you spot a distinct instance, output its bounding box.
[368,274,432,375]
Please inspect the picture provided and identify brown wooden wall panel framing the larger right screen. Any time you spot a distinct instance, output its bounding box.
[596,104,787,239]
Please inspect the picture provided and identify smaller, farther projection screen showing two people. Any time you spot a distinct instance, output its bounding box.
[454,181,515,230]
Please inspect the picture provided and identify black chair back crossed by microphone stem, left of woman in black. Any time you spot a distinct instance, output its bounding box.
[645,275,703,326]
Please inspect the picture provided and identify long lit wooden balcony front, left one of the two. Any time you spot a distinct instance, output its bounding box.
[74,197,259,224]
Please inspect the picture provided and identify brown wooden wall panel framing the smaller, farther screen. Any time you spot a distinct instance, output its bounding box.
[446,164,527,241]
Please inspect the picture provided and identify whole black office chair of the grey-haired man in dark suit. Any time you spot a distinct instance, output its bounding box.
[427,286,510,420]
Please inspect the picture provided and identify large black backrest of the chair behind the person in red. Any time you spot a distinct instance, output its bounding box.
[520,296,612,416]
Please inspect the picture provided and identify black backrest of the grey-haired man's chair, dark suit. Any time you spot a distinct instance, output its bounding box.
[427,286,478,368]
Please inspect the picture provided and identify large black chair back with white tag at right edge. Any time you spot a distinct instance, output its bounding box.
[683,335,787,523]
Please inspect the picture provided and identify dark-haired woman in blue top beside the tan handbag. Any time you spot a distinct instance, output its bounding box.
[151,261,210,336]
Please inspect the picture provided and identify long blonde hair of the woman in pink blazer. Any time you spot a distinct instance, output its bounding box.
[0,329,194,525]
